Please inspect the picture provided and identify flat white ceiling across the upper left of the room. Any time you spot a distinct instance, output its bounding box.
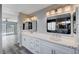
[3,4,51,14]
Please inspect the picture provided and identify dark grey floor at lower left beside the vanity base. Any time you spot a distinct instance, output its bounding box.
[3,45,32,54]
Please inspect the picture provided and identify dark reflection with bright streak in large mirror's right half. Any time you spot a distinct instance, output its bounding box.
[56,17,71,34]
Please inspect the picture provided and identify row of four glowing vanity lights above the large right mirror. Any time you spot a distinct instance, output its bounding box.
[46,5,73,17]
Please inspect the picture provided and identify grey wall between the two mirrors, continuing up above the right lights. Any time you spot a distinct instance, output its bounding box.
[31,5,64,33]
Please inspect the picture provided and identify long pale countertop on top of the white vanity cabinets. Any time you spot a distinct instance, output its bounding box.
[22,31,78,48]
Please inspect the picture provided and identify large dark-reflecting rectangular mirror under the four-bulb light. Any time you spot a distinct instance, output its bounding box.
[47,14,71,34]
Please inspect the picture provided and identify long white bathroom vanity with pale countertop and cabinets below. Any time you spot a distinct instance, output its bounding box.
[22,31,79,54]
